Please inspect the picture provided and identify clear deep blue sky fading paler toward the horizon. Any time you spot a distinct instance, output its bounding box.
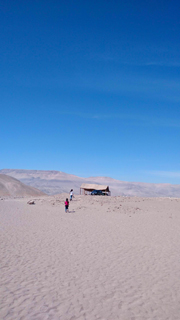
[0,0,180,184]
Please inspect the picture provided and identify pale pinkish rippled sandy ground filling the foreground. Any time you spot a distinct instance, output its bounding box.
[0,195,180,320]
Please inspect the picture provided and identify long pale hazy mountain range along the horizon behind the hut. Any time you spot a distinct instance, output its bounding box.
[0,169,180,198]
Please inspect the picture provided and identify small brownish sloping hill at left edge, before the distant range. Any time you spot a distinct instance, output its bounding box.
[0,174,45,197]
